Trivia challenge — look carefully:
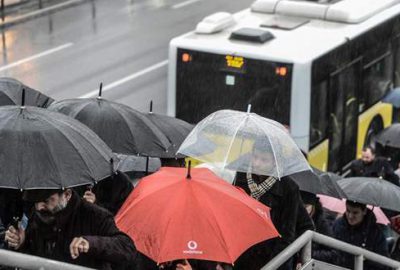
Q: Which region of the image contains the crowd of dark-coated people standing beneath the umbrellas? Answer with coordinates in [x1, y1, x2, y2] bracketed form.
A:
[0, 147, 400, 270]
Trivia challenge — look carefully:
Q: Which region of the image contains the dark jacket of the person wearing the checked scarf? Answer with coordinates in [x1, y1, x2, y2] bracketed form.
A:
[235, 173, 304, 270]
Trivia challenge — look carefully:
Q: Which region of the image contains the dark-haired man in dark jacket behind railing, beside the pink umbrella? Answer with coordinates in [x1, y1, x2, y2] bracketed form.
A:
[333, 200, 389, 270]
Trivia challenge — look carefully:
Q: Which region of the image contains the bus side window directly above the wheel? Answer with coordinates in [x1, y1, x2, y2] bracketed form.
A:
[362, 54, 393, 108]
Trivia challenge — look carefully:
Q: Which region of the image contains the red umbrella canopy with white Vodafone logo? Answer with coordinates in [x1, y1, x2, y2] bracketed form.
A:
[116, 167, 279, 264]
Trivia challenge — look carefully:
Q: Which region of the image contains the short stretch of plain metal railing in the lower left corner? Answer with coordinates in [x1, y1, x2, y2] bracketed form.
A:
[0, 249, 93, 270]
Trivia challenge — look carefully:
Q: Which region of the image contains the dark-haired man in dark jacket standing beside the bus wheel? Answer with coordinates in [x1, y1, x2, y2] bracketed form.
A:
[349, 146, 400, 186]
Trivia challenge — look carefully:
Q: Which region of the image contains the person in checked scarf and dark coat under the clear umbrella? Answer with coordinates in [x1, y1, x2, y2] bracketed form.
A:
[234, 140, 305, 270]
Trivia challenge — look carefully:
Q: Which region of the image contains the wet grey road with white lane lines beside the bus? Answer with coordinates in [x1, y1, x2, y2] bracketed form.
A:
[0, 0, 253, 113]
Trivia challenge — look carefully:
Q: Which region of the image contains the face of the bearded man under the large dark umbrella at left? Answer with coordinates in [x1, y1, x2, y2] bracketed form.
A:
[35, 191, 70, 223]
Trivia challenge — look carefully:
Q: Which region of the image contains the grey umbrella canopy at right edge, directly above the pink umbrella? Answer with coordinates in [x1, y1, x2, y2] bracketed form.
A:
[338, 177, 400, 211]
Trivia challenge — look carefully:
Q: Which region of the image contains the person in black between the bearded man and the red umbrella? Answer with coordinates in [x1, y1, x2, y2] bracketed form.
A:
[83, 171, 133, 215]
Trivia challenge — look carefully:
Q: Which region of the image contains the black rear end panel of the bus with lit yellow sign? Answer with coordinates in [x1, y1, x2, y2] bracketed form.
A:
[176, 49, 293, 125]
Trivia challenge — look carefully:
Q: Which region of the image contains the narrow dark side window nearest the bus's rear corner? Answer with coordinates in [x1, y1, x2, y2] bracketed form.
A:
[310, 81, 329, 147]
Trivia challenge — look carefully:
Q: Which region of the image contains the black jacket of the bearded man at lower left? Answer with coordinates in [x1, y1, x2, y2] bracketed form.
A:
[21, 193, 136, 269]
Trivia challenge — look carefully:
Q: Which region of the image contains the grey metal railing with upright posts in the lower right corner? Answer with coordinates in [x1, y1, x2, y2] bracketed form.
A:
[262, 231, 400, 270]
